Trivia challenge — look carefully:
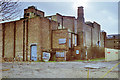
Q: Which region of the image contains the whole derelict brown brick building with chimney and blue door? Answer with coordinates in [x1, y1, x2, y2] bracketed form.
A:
[2, 6, 105, 61]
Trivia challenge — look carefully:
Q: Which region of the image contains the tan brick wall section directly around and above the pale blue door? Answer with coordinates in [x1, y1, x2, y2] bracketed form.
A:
[28, 17, 43, 60]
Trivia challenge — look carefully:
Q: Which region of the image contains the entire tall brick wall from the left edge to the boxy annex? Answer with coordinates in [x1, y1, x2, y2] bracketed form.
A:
[1, 17, 58, 60]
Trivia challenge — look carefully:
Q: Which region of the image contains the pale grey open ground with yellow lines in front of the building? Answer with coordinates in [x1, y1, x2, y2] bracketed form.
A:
[2, 61, 120, 78]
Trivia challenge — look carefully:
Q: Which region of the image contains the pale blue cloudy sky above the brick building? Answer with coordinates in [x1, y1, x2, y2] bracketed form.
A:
[15, 0, 118, 34]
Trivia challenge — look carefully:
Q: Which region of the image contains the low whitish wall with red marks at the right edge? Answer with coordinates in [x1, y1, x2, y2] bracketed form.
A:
[105, 48, 120, 61]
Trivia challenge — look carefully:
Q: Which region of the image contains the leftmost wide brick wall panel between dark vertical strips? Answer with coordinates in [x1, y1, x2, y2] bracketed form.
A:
[4, 22, 14, 58]
